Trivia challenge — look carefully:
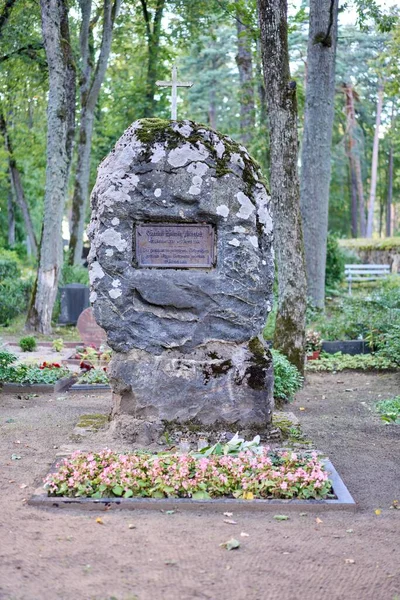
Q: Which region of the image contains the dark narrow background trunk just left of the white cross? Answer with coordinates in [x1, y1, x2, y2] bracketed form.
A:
[140, 0, 165, 117]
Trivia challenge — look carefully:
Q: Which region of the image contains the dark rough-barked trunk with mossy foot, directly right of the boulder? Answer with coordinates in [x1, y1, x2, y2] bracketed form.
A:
[258, 0, 306, 372]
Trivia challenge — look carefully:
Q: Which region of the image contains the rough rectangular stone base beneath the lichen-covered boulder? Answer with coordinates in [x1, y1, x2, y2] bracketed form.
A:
[109, 338, 273, 432]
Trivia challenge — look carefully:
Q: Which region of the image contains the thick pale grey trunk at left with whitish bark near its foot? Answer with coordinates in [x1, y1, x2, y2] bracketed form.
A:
[26, 0, 75, 334]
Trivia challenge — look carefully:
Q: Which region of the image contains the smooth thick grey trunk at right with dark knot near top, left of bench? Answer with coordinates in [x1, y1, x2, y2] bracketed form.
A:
[300, 0, 338, 309]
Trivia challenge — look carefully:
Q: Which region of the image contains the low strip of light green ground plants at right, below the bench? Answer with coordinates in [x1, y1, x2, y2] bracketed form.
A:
[306, 352, 398, 372]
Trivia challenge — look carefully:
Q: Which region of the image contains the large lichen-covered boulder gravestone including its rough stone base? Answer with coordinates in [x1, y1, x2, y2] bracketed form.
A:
[88, 119, 274, 441]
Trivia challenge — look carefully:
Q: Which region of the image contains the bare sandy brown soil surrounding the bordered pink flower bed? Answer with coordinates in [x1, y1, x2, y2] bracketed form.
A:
[0, 373, 400, 600]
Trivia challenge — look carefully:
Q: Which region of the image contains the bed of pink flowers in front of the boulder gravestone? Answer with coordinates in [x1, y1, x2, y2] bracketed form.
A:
[44, 446, 332, 499]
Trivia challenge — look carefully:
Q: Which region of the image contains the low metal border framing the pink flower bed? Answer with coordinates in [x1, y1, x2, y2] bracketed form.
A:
[28, 455, 357, 512]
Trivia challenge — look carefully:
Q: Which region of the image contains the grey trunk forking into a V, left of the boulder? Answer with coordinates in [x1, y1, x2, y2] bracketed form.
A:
[69, 0, 121, 264]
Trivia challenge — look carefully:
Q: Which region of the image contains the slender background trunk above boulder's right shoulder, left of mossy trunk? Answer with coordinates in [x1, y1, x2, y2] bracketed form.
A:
[236, 11, 255, 147]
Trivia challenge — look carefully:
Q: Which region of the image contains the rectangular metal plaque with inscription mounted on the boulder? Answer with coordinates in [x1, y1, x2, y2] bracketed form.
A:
[136, 223, 214, 268]
